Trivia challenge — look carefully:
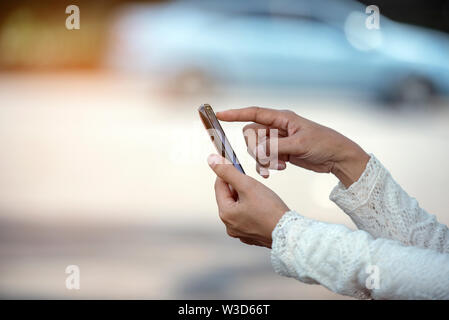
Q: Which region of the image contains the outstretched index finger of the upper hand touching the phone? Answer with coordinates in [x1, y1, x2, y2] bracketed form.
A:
[217, 107, 294, 130]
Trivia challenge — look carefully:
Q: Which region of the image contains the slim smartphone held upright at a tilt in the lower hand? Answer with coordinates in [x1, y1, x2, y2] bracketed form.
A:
[198, 104, 245, 174]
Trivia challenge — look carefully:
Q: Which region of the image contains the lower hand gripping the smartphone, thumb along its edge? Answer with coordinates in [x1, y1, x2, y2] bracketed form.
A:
[207, 154, 289, 248]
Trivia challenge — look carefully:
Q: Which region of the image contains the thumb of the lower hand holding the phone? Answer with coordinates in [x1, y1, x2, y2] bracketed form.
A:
[207, 154, 248, 190]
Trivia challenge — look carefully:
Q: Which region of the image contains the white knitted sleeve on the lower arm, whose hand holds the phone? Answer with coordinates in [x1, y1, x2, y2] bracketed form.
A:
[271, 211, 449, 299]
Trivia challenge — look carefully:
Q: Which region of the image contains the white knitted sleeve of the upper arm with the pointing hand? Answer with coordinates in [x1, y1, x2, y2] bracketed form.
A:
[330, 155, 449, 253]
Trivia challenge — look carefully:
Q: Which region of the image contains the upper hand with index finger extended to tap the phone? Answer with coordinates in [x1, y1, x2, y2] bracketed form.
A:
[217, 107, 370, 187]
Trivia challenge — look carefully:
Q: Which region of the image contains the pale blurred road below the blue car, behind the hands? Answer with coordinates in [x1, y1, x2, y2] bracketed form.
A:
[0, 73, 449, 299]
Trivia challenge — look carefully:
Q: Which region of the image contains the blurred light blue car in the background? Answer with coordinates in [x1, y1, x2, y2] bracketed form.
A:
[107, 0, 449, 103]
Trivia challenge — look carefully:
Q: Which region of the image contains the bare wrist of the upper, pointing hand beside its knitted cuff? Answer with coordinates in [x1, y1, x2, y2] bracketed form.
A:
[331, 143, 370, 188]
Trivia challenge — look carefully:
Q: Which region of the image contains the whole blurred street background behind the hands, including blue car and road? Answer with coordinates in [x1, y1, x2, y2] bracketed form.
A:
[0, 0, 449, 299]
